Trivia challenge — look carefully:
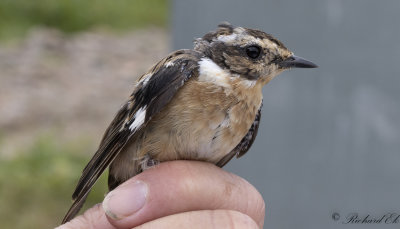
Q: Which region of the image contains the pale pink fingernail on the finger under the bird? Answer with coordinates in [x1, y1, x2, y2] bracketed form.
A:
[103, 181, 148, 220]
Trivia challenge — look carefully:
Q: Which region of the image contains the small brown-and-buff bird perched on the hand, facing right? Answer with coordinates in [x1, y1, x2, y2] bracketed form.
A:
[62, 22, 317, 223]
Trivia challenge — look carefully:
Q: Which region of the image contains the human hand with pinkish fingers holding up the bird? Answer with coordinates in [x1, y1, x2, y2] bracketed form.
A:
[58, 161, 265, 229]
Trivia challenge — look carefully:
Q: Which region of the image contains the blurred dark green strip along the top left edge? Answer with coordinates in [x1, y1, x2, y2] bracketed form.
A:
[0, 0, 168, 39]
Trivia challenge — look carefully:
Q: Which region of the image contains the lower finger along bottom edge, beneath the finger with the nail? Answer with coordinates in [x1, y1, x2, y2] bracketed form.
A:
[135, 210, 259, 229]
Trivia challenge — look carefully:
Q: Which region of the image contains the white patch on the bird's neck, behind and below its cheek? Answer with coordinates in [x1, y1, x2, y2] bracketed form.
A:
[199, 58, 231, 88]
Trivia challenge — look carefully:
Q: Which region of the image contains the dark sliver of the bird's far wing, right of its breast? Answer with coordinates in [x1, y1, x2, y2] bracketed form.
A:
[216, 104, 262, 167]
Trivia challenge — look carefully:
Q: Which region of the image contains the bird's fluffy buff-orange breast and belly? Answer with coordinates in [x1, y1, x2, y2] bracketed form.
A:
[139, 74, 262, 163]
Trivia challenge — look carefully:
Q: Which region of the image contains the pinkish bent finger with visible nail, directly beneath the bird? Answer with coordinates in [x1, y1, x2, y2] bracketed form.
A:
[103, 161, 265, 228]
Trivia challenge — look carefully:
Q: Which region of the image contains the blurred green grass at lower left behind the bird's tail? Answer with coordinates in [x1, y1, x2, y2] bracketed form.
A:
[0, 135, 107, 228]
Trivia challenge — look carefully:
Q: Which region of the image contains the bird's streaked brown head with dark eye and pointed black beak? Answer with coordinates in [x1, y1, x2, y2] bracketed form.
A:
[194, 23, 317, 84]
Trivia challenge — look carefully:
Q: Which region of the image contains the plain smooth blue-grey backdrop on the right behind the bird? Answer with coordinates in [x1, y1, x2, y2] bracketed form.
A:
[171, 0, 400, 229]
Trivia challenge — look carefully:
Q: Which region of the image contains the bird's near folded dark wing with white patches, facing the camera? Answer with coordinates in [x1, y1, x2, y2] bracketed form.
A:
[63, 50, 201, 223]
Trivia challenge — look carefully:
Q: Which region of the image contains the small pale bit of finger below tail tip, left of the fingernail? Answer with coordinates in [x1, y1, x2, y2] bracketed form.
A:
[56, 204, 115, 229]
